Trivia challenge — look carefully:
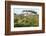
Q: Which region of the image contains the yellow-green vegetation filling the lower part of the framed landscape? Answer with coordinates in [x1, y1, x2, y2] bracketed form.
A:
[14, 15, 39, 27]
